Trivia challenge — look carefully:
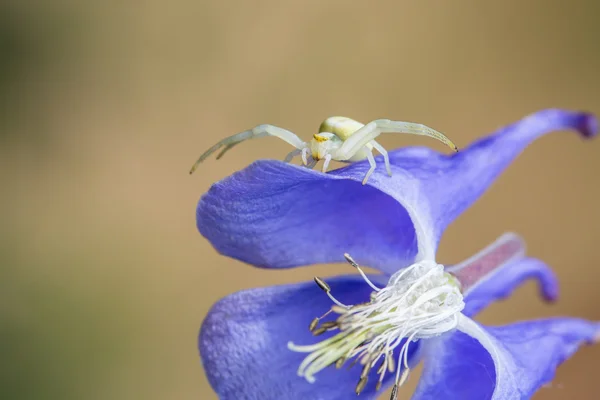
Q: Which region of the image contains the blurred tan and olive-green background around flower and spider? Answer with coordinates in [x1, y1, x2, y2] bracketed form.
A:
[0, 0, 600, 400]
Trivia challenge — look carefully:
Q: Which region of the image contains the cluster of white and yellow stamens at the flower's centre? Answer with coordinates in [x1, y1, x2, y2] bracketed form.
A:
[288, 255, 465, 394]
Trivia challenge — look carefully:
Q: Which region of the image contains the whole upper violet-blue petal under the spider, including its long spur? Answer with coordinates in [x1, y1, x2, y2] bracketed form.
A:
[196, 110, 596, 274]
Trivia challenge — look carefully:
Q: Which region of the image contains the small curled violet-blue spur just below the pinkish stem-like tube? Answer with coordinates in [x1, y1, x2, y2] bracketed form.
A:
[463, 258, 559, 317]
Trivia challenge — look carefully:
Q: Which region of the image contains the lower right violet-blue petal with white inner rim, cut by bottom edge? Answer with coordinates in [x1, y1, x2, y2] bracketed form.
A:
[413, 317, 600, 400]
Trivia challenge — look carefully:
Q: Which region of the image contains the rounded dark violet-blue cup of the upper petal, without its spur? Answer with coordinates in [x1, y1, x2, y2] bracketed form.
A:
[197, 160, 417, 275]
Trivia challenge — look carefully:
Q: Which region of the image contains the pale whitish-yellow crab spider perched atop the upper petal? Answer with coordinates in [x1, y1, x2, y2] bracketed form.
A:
[190, 117, 458, 185]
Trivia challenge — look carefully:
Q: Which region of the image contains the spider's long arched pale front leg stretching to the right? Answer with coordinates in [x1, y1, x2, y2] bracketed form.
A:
[333, 119, 458, 160]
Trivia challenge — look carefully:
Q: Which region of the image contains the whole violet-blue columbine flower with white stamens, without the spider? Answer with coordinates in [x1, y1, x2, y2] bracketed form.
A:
[197, 110, 600, 400]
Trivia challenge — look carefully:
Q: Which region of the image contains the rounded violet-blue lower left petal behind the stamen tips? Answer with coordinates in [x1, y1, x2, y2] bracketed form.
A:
[199, 276, 418, 400]
